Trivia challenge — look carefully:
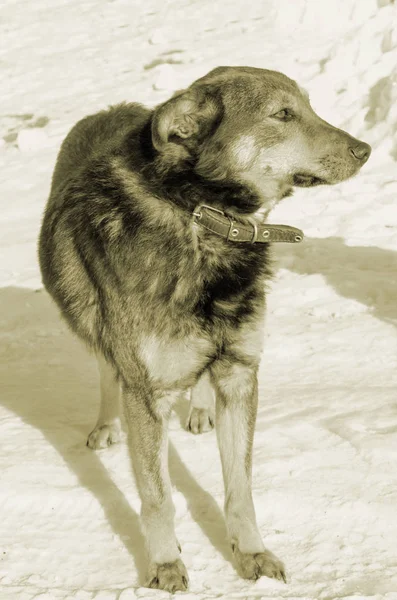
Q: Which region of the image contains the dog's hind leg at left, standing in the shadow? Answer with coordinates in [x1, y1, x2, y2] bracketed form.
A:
[87, 355, 121, 450]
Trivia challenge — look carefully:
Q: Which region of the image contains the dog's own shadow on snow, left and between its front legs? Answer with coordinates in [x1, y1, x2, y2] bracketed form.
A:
[0, 287, 232, 585]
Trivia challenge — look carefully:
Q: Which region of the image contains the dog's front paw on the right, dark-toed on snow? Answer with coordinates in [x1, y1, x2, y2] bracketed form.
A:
[232, 545, 287, 583]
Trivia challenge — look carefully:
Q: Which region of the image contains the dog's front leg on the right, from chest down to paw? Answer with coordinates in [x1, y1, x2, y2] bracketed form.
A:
[212, 360, 285, 581]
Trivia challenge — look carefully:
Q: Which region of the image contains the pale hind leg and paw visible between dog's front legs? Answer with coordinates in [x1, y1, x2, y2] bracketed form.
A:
[186, 371, 215, 433]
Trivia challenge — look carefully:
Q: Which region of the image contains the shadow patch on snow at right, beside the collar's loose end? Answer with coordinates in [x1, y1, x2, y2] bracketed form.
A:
[273, 237, 397, 325]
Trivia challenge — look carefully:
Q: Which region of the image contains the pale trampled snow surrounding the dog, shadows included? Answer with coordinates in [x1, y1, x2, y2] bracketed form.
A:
[0, 0, 397, 600]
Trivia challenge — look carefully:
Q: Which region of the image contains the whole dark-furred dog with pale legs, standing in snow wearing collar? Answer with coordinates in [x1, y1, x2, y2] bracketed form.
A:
[39, 67, 371, 592]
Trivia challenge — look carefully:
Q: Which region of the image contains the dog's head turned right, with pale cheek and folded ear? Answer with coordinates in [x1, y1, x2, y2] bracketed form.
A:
[152, 67, 371, 209]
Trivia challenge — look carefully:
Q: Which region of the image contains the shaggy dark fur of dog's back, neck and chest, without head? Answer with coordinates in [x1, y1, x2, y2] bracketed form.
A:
[40, 99, 269, 384]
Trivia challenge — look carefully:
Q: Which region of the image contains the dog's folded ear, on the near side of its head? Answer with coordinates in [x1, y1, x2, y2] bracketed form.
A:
[152, 88, 222, 159]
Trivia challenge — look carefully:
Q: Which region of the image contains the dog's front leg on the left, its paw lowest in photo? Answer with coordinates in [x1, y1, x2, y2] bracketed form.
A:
[122, 385, 188, 593]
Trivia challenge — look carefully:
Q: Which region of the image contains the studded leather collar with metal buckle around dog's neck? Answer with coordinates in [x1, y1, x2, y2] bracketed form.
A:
[193, 204, 304, 244]
